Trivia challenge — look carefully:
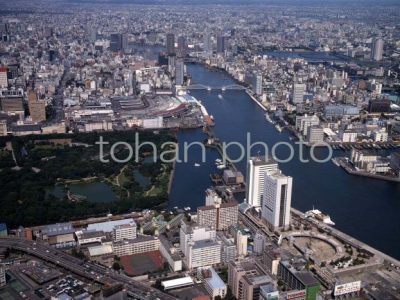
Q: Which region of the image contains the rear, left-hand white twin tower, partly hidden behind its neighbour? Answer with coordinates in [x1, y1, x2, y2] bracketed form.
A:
[246, 156, 278, 208]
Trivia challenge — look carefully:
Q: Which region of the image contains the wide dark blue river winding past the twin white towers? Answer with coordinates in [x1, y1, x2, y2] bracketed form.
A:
[169, 64, 400, 259]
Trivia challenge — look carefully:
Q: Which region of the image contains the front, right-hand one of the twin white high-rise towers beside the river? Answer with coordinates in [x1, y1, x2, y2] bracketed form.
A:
[262, 170, 293, 230]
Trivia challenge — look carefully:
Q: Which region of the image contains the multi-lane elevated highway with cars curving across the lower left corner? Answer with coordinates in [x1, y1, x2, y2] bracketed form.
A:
[0, 237, 176, 300]
